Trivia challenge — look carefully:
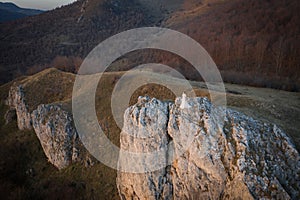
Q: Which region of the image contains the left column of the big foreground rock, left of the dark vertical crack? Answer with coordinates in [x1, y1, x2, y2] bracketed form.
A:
[117, 98, 172, 199]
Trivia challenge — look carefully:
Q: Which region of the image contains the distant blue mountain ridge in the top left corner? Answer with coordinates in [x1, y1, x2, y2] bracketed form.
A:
[0, 2, 44, 22]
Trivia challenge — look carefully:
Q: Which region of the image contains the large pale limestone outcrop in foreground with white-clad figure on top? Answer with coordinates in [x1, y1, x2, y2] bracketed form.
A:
[117, 97, 300, 199]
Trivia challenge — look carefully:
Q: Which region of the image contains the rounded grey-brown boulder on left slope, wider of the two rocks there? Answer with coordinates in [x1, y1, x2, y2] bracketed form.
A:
[31, 104, 79, 169]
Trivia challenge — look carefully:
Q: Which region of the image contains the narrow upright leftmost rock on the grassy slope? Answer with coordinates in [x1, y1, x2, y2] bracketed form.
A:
[7, 85, 32, 130]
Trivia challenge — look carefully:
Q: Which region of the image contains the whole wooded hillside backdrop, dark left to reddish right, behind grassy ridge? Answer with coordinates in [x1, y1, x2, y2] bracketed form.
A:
[0, 0, 300, 91]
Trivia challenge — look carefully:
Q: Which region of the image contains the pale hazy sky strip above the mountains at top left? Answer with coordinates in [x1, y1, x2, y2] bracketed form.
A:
[0, 0, 76, 10]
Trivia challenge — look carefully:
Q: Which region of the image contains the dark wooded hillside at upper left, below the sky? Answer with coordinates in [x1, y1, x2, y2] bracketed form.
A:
[0, 0, 154, 83]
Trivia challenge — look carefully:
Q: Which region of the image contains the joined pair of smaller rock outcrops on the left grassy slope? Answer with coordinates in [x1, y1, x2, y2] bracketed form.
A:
[5, 85, 86, 169]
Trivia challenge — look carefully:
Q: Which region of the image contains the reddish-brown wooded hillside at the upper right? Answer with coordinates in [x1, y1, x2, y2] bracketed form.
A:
[165, 0, 300, 89]
